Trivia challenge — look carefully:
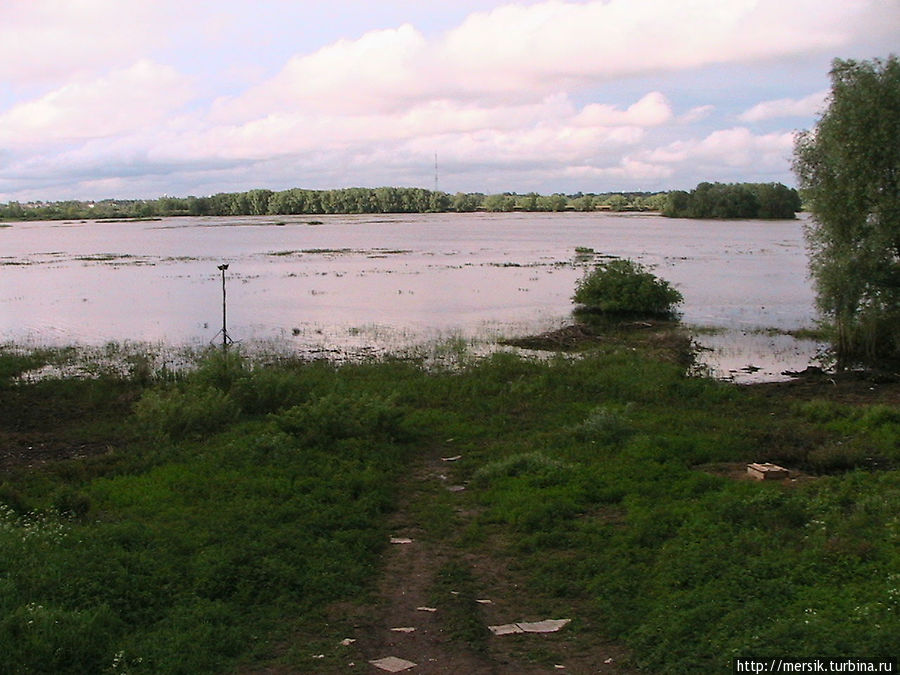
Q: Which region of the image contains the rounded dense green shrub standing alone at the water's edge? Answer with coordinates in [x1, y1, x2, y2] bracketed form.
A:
[572, 259, 683, 316]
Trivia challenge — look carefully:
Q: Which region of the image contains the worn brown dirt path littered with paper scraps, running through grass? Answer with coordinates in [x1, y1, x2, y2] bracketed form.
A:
[344, 452, 634, 675]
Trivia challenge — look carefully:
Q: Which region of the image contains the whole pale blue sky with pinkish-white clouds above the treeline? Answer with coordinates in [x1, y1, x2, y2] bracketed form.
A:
[0, 0, 900, 202]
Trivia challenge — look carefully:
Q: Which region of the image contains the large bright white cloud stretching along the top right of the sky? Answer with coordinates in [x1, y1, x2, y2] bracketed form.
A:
[216, 0, 874, 122]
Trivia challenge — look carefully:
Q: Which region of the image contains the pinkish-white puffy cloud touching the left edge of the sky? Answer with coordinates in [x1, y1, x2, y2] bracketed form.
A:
[0, 60, 191, 146]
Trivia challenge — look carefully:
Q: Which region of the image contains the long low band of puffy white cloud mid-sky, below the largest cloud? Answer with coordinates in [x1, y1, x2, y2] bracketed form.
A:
[160, 92, 671, 172]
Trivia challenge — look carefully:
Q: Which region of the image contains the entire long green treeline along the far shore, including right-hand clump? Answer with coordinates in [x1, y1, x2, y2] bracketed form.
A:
[0, 183, 800, 220]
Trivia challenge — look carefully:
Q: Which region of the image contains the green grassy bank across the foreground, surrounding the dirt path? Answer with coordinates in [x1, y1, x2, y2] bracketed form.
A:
[0, 329, 900, 674]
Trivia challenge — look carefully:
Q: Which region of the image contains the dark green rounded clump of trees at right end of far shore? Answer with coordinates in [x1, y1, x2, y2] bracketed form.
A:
[662, 183, 802, 219]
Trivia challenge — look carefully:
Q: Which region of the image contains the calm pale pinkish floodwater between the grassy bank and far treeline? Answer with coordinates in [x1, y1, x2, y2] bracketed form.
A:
[0, 213, 817, 379]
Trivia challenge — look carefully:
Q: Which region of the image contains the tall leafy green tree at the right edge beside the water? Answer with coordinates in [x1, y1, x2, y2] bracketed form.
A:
[793, 56, 900, 366]
